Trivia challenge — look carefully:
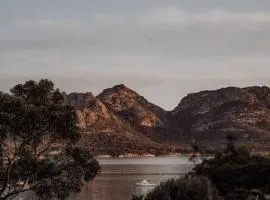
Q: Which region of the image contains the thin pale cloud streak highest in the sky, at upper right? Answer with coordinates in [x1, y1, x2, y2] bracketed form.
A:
[139, 7, 270, 25]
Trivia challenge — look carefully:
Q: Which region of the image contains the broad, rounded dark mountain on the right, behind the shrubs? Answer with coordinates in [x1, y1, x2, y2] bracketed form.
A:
[170, 87, 270, 151]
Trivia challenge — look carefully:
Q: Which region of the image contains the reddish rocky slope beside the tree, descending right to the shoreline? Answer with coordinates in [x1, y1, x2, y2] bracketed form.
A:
[64, 93, 177, 155]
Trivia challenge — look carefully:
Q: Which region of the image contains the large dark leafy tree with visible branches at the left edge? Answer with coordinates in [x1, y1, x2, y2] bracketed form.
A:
[0, 80, 100, 200]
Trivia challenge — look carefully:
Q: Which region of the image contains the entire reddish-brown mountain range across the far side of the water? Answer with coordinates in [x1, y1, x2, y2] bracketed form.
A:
[65, 85, 270, 154]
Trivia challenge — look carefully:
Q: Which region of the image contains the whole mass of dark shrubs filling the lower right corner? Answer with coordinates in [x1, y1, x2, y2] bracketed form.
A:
[133, 136, 270, 200]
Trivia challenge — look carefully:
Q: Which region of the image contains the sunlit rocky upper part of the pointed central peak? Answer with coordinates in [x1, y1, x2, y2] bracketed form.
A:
[97, 84, 167, 127]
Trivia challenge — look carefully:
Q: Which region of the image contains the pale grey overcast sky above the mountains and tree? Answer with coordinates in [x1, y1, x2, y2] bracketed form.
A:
[0, 0, 270, 110]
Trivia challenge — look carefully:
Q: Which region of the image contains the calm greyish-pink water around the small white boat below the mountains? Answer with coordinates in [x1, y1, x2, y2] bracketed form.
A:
[73, 157, 194, 200]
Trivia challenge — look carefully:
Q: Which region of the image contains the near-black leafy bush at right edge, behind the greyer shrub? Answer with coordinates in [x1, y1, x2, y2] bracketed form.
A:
[194, 136, 270, 200]
